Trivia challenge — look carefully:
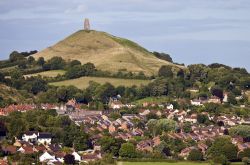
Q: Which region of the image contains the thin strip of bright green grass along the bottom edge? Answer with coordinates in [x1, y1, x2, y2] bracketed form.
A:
[117, 162, 209, 165]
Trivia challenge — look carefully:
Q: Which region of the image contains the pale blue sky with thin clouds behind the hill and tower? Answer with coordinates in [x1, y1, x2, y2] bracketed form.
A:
[0, 0, 250, 71]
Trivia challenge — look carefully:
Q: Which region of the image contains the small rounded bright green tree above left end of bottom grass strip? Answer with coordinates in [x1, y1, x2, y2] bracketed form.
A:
[119, 143, 136, 158]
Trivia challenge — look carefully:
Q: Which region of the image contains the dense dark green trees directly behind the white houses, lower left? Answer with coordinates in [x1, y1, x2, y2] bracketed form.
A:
[0, 110, 92, 151]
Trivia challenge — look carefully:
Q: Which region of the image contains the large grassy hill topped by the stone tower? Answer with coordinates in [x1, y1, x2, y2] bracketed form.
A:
[34, 30, 181, 75]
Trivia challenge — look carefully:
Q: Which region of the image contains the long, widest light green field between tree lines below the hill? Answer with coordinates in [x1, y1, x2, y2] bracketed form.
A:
[50, 77, 150, 89]
